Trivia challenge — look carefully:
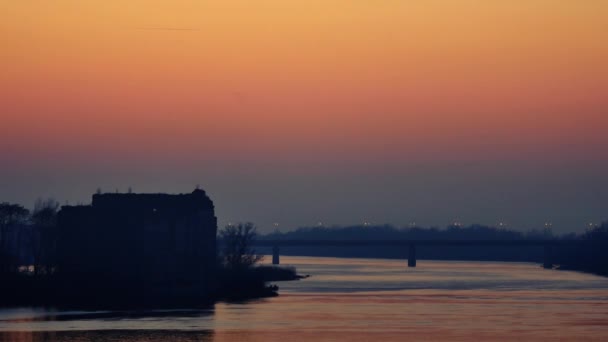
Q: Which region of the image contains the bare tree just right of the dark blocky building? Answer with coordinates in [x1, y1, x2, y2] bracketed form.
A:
[220, 223, 263, 269]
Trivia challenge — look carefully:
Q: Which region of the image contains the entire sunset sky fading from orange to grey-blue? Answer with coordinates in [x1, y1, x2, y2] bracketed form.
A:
[0, 0, 608, 231]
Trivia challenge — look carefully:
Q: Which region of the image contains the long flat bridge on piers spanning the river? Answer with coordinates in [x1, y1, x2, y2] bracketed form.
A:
[253, 240, 608, 268]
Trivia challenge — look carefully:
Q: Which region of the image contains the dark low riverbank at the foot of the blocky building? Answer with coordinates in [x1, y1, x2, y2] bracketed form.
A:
[0, 266, 306, 309]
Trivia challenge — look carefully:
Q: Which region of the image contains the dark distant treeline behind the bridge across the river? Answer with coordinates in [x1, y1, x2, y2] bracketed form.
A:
[260, 222, 608, 275]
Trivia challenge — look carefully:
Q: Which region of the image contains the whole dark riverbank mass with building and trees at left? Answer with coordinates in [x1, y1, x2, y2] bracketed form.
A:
[0, 189, 300, 307]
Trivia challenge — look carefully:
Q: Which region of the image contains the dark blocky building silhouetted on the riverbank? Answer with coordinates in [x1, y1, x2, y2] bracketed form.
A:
[57, 189, 217, 300]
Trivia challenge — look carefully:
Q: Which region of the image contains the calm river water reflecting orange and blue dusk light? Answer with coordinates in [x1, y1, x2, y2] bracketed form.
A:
[0, 257, 608, 342]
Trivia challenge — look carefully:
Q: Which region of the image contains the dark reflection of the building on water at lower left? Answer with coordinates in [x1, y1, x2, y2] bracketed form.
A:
[0, 307, 214, 342]
